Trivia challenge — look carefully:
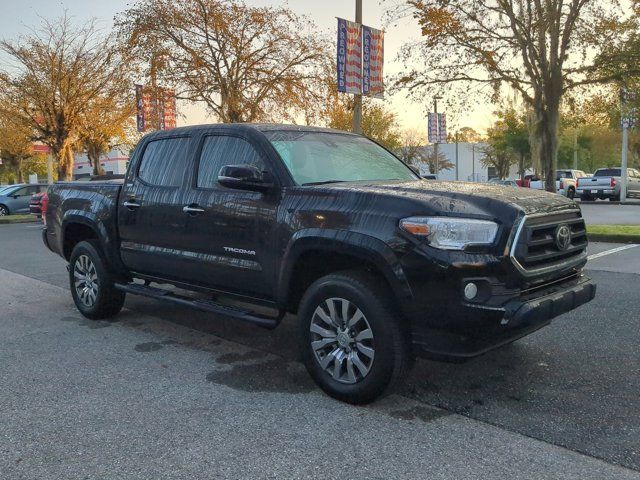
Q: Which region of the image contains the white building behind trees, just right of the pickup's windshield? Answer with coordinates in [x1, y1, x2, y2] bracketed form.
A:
[419, 143, 519, 182]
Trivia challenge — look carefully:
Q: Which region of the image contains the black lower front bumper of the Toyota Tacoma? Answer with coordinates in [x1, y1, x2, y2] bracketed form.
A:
[413, 276, 596, 362]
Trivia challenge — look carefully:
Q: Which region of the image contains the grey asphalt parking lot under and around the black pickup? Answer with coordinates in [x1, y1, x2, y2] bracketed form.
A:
[0, 223, 640, 479]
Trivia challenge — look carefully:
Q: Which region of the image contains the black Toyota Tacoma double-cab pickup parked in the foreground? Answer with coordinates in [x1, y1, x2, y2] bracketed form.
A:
[44, 125, 595, 403]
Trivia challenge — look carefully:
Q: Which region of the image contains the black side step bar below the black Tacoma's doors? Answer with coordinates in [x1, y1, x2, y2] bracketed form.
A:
[114, 283, 285, 329]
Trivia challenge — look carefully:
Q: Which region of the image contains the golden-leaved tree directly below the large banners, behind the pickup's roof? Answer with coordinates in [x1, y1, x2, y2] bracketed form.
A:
[325, 94, 402, 151]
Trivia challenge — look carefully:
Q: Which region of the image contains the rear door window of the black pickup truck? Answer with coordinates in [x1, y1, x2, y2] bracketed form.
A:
[138, 137, 190, 187]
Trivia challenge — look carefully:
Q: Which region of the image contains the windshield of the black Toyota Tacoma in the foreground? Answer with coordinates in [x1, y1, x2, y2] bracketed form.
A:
[265, 131, 418, 185]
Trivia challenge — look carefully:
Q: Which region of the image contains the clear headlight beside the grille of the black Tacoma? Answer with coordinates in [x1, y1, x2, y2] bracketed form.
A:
[400, 217, 498, 250]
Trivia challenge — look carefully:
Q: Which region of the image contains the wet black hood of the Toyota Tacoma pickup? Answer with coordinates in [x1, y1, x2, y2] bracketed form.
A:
[325, 180, 578, 215]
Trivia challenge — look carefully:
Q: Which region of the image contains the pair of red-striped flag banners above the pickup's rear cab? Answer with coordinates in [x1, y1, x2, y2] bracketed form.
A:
[136, 85, 176, 132]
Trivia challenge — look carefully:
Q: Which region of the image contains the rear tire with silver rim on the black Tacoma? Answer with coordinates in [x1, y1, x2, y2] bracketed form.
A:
[69, 240, 125, 320]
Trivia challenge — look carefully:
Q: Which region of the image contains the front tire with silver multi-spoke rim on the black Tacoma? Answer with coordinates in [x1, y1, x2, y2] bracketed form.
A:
[298, 270, 411, 404]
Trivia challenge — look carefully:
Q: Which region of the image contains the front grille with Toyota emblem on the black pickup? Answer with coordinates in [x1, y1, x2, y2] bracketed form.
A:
[512, 212, 587, 271]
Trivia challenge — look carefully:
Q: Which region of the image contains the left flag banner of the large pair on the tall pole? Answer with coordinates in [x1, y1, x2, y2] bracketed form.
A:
[337, 18, 362, 94]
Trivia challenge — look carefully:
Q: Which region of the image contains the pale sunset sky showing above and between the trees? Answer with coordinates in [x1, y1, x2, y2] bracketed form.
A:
[0, 0, 493, 134]
